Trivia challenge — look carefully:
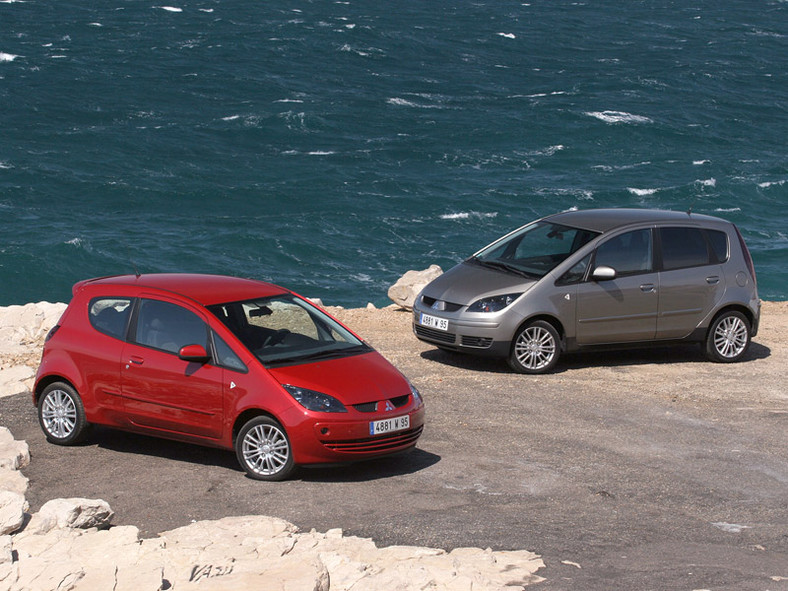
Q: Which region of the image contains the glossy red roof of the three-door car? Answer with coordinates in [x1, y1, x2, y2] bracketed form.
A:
[74, 273, 290, 306]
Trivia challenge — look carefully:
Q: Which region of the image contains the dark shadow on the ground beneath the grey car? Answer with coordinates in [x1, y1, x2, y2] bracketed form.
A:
[421, 342, 771, 374]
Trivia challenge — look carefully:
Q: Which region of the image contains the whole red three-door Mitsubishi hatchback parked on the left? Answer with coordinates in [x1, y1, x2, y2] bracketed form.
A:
[33, 274, 424, 480]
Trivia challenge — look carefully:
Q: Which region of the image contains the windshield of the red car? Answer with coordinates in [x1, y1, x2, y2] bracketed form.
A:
[208, 295, 370, 367]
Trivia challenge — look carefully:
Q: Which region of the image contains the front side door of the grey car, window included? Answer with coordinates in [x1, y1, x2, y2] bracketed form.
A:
[576, 228, 659, 345]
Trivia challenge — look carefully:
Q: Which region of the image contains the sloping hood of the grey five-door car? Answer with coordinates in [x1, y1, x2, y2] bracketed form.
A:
[422, 263, 536, 306]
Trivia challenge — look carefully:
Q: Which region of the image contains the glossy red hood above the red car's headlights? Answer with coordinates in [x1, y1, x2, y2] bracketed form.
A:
[268, 351, 410, 405]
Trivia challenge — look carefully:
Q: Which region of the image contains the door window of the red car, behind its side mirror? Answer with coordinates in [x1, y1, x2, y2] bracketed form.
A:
[134, 299, 208, 353]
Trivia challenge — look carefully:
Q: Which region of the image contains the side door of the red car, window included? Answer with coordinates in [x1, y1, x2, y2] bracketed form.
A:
[121, 297, 224, 439]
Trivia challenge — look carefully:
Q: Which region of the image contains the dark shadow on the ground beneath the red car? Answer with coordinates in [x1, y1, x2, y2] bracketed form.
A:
[91, 426, 441, 482]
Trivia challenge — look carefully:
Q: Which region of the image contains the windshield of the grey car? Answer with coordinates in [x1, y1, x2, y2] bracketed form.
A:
[468, 221, 599, 279]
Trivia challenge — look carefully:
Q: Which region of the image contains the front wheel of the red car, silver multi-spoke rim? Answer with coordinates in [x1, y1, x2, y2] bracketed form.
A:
[235, 415, 295, 481]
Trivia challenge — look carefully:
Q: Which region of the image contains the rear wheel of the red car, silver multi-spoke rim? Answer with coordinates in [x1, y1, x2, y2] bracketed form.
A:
[38, 382, 88, 445]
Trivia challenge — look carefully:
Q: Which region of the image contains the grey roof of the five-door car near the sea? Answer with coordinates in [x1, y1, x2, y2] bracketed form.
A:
[543, 208, 724, 232]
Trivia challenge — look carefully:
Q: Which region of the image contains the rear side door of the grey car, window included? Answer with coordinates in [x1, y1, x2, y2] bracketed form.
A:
[657, 227, 727, 339]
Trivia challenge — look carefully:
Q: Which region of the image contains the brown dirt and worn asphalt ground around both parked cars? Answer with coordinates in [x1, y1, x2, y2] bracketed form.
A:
[0, 302, 788, 591]
